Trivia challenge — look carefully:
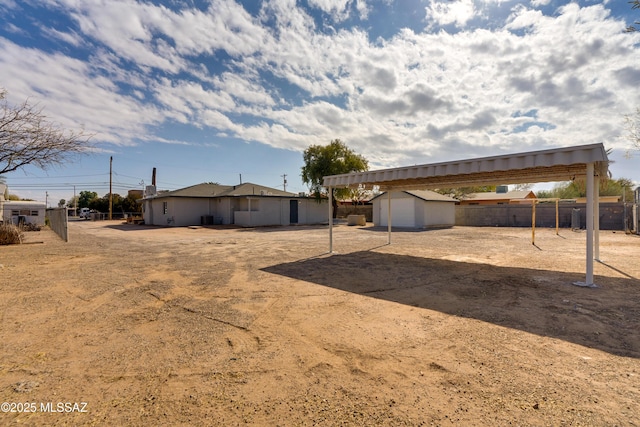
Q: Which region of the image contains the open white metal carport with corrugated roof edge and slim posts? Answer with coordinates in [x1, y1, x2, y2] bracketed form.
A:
[323, 143, 609, 286]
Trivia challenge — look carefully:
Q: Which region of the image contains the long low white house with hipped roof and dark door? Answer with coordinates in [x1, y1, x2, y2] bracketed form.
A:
[142, 183, 329, 227]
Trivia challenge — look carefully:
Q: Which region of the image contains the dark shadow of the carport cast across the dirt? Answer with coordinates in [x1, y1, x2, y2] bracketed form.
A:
[262, 251, 640, 358]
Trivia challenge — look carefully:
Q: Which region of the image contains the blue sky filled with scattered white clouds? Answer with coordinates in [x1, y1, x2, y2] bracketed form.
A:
[0, 0, 640, 206]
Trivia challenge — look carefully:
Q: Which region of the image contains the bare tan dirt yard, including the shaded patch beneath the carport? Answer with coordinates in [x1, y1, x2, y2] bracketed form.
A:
[0, 221, 640, 426]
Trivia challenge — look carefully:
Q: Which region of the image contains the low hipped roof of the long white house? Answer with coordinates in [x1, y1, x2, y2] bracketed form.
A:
[147, 182, 297, 199]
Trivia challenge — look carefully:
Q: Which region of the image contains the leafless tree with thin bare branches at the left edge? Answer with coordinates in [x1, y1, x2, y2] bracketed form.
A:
[0, 88, 92, 176]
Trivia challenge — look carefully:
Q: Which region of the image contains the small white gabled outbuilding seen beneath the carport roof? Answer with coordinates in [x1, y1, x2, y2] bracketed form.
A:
[371, 190, 457, 228]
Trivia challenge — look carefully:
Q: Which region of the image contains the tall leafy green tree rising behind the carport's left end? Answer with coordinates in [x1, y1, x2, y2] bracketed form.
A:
[301, 139, 369, 218]
